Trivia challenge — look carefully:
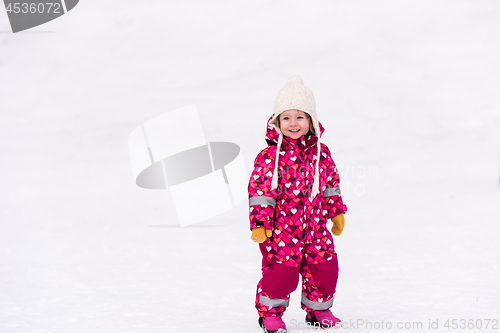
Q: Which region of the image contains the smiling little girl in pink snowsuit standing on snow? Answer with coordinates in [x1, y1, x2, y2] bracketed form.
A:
[248, 76, 347, 332]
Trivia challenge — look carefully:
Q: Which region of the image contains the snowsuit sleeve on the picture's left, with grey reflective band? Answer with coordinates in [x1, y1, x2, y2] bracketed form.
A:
[248, 146, 278, 229]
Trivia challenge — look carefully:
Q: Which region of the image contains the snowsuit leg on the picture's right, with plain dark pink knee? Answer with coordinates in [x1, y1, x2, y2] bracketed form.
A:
[300, 235, 339, 315]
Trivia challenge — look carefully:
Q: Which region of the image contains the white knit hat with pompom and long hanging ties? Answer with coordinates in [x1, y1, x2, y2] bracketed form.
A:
[269, 75, 321, 197]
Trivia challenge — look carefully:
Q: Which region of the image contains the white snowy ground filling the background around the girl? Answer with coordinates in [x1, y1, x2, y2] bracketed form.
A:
[0, 0, 500, 333]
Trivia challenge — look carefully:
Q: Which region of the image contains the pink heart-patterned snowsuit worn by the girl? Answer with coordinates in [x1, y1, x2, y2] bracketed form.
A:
[248, 117, 347, 317]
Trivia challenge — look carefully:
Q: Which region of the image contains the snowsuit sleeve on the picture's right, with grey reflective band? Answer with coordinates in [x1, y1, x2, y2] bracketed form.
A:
[322, 145, 347, 219]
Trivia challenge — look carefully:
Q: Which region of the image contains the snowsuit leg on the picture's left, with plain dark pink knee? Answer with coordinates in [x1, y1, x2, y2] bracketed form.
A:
[255, 242, 300, 317]
